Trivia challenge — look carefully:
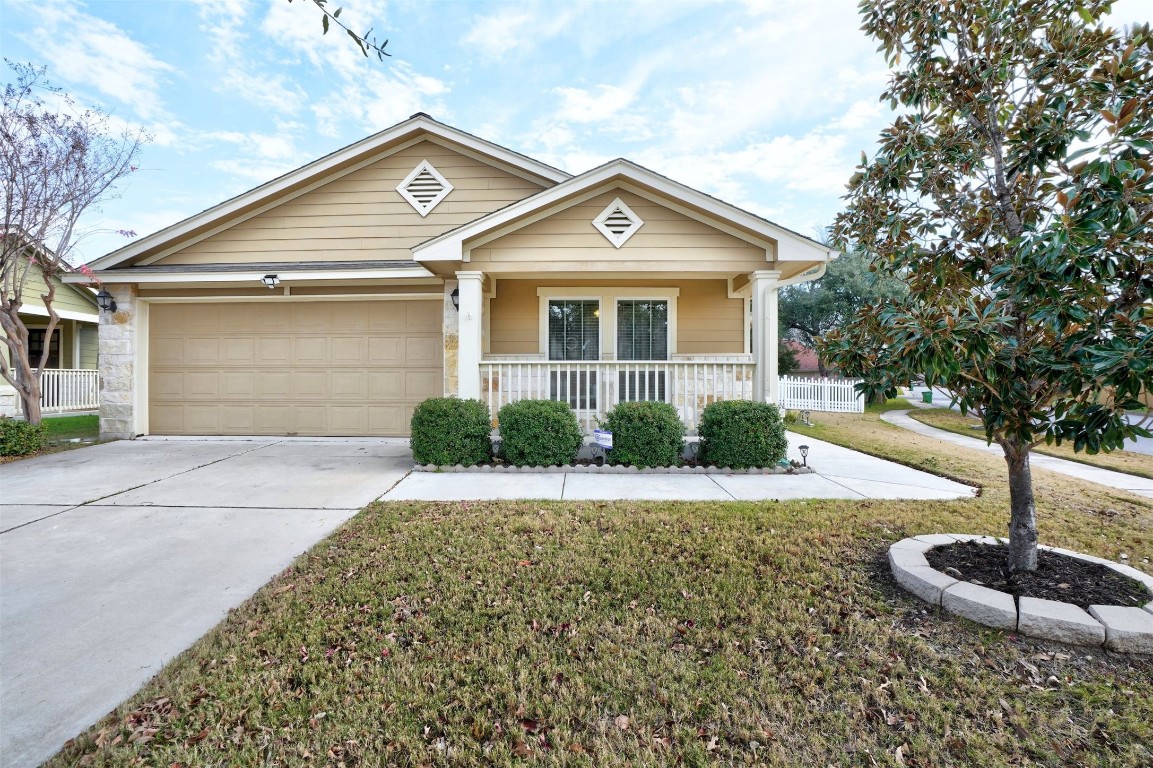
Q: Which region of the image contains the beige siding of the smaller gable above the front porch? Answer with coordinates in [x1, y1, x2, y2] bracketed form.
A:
[472, 190, 770, 274]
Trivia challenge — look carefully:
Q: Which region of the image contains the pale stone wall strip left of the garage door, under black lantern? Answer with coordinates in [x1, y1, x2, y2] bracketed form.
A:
[99, 285, 136, 439]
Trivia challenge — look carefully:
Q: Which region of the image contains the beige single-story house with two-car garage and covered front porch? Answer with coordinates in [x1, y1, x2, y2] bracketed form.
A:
[70, 113, 836, 437]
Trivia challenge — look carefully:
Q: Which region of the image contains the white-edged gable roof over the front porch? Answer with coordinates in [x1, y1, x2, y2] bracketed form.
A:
[413, 158, 837, 262]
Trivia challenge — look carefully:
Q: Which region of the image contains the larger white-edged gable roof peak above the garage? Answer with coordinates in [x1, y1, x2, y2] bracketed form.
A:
[91, 112, 572, 270]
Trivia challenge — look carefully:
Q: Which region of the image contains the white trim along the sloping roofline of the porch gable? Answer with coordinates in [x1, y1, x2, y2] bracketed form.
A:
[412, 159, 836, 262]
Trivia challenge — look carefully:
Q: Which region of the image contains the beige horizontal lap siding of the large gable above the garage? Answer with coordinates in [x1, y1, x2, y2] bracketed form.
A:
[158, 142, 541, 264]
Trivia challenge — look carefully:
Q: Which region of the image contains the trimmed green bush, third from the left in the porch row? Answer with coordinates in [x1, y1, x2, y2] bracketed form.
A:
[604, 402, 685, 467]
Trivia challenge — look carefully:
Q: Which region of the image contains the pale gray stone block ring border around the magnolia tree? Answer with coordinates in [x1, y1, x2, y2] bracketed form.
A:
[889, 534, 1153, 654]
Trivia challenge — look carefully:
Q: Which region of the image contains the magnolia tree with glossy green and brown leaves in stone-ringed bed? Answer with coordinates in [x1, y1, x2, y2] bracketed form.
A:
[824, 0, 1153, 572]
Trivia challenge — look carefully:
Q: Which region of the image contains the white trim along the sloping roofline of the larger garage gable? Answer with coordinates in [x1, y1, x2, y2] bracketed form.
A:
[91, 114, 572, 269]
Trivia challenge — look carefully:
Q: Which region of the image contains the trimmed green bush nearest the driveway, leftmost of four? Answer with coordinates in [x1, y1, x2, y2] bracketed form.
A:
[410, 398, 492, 467]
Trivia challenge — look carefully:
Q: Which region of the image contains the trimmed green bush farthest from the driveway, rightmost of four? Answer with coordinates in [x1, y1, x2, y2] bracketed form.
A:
[698, 400, 789, 469]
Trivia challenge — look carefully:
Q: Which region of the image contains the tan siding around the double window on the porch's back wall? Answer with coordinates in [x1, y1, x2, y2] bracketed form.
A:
[489, 277, 745, 356]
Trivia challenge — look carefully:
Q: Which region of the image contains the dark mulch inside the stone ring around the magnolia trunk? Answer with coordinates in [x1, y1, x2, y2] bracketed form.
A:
[925, 542, 1153, 609]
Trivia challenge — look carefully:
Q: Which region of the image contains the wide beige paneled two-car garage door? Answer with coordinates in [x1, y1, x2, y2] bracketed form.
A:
[149, 300, 443, 436]
